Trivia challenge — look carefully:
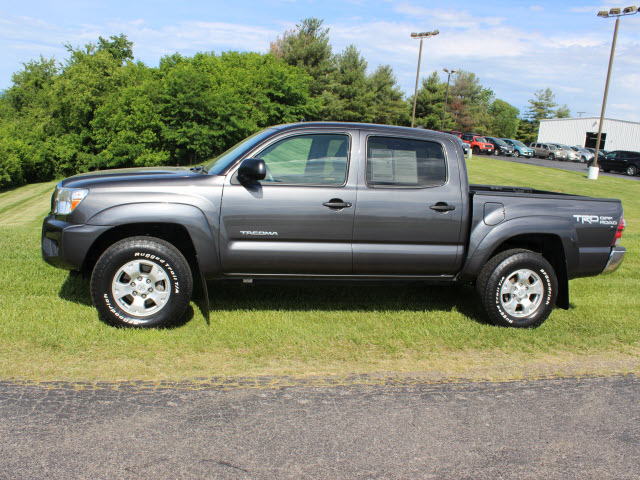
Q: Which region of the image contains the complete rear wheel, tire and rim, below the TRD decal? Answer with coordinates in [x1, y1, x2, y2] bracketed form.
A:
[476, 249, 558, 328]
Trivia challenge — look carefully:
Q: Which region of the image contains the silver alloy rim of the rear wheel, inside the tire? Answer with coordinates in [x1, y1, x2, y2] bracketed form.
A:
[500, 268, 544, 318]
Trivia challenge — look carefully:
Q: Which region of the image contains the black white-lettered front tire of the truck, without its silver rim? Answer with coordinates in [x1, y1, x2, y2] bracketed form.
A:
[91, 238, 193, 328]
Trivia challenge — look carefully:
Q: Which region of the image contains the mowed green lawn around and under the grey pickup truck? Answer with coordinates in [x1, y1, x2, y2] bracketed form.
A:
[0, 156, 640, 383]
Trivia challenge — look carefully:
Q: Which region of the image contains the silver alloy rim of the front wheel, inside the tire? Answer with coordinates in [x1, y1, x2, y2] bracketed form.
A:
[111, 260, 171, 317]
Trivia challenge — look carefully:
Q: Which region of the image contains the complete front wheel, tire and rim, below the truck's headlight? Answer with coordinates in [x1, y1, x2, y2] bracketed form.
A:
[91, 237, 193, 328]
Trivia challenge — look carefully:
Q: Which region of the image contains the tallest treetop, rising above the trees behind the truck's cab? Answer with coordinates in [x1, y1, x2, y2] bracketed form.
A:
[270, 17, 336, 96]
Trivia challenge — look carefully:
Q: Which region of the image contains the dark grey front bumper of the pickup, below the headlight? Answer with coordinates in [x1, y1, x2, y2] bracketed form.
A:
[41, 215, 111, 270]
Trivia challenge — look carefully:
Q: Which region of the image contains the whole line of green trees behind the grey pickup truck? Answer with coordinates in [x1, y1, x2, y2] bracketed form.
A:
[0, 18, 569, 188]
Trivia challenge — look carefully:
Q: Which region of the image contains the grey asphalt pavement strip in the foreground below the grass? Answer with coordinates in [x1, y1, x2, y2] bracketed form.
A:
[0, 376, 640, 479]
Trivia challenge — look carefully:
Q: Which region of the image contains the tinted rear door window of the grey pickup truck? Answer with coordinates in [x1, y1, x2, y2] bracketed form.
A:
[367, 137, 447, 187]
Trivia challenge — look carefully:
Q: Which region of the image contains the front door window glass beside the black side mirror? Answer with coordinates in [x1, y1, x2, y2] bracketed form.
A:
[256, 134, 349, 186]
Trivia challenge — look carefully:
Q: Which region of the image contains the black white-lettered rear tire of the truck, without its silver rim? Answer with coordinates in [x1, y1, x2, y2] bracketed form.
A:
[487, 253, 558, 328]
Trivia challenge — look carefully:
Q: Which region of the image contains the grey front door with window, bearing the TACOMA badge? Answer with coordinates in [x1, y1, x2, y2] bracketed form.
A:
[220, 130, 358, 275]
